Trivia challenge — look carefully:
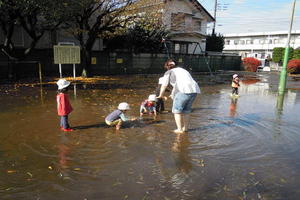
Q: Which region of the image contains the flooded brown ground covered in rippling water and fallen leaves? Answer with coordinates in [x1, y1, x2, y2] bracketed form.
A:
[0, 73, 300, 200]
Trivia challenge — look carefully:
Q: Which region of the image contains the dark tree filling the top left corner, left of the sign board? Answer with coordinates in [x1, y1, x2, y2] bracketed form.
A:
[0, 0, 64, 61]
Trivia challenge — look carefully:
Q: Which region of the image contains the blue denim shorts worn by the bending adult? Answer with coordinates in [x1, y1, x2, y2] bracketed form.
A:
[172, 92, 197, 114]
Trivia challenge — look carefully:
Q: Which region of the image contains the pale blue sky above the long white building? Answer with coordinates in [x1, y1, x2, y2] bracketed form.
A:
[198, 0, 300, 34]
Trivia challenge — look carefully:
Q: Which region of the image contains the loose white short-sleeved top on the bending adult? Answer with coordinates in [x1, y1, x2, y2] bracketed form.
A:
[162, 67, 201, 97]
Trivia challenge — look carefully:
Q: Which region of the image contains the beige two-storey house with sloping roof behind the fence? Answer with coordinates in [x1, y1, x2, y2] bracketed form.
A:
[163, 0, 214, 54]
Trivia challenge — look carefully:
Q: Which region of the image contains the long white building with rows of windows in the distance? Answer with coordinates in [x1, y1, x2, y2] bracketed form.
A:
[223, 30, 300, 59]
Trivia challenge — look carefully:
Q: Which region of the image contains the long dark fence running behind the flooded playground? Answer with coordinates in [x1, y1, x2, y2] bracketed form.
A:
[0, 49, 241, 78]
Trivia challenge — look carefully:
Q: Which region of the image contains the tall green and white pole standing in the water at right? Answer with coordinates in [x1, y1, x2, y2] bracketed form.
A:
[278, 0, 296, 95]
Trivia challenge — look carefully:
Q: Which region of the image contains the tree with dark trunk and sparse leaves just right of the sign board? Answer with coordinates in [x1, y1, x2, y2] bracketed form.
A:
[64, 0, 133, 76]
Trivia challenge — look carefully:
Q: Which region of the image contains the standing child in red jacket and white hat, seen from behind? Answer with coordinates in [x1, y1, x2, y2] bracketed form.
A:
[56, 79, 73, 131]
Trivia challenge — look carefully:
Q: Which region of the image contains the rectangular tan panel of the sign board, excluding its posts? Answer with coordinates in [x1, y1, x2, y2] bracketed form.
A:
[53, 45, 80, 64]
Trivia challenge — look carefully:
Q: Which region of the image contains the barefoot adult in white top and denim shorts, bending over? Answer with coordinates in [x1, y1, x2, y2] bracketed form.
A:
[157, 59, 201, 133]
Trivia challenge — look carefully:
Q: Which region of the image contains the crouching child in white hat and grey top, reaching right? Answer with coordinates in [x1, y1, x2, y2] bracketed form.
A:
[105, 102, 135, 130]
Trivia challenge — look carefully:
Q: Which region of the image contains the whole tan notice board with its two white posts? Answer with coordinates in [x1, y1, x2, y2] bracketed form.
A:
[53, 42, 80, 79]
